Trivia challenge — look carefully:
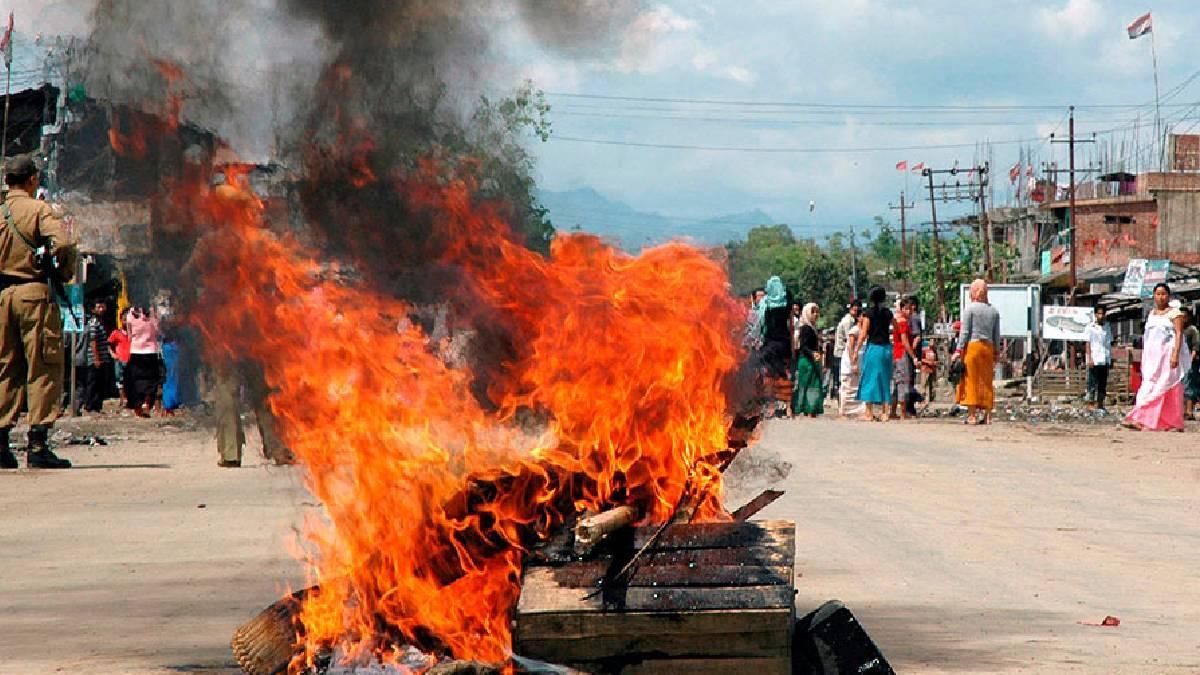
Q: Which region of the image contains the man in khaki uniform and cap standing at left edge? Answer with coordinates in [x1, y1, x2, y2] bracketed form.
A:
[0, 155, 76, 468]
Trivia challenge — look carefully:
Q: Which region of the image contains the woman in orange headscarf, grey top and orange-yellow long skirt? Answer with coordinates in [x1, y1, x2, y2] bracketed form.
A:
[954, 279, 1000, 424]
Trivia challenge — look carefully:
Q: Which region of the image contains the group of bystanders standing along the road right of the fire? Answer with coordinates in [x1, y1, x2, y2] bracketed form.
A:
[744, 276, 1200, 431]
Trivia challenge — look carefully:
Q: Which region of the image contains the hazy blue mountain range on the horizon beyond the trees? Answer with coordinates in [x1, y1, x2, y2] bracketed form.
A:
[538, 187, 775, 252]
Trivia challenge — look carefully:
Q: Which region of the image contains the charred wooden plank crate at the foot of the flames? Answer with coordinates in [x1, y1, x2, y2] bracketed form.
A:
[514, 521, 796, 675]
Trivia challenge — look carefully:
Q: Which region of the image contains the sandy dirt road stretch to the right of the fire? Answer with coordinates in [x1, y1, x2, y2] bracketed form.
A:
[731, 420, 1200, 674]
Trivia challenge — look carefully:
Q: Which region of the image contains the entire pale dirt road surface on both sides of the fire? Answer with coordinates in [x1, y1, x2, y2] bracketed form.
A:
[0, 408, 1200, 675]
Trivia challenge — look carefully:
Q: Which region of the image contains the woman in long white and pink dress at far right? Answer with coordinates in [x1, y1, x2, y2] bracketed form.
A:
[1122, 283, 1192, 431]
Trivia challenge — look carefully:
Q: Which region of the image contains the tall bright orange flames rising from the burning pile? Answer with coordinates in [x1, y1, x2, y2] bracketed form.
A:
[176, 157, 743, 667]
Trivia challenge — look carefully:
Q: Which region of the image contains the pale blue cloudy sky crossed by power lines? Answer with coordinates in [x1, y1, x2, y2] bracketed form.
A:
[10, 0, 1200, 235]
